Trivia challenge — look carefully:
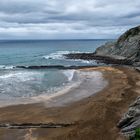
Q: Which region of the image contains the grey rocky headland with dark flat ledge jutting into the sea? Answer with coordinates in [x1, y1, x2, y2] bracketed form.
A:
[64, 26, 140, 67]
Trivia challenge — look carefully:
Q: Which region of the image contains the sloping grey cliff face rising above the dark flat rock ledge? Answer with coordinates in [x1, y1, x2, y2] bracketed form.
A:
[95, 26, 140, 66]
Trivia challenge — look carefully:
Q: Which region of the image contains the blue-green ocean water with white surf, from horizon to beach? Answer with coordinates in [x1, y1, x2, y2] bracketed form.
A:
[0, 40, 109, 104]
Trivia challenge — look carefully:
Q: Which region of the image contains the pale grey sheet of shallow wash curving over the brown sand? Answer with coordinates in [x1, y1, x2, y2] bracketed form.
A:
[33, 70, 107, 107]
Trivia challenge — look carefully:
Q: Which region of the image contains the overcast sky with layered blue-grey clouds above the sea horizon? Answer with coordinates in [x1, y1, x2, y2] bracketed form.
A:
[0, 0, 140, 39]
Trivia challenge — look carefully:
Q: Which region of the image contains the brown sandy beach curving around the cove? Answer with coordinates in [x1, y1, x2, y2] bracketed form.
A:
[0, 67, 140, 140]
